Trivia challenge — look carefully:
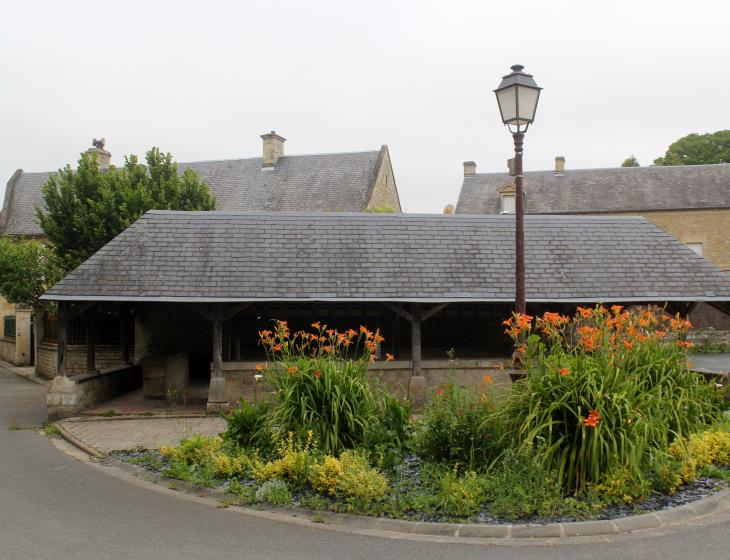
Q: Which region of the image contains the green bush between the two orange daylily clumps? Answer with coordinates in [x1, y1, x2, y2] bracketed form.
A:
[414, 376, 496, 469]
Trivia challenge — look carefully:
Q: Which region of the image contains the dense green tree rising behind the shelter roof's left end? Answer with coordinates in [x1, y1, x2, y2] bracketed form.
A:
[36, 148, 215, 272]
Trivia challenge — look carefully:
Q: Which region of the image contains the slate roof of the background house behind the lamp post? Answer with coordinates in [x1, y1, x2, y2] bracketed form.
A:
[456, 164, 730, 214]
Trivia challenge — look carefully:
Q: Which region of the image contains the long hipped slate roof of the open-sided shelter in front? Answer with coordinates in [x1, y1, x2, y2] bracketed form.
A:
[43, 211, 730, 303]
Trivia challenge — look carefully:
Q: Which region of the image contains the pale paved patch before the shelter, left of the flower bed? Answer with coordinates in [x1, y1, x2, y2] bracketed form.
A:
[59, 416, 226, 453]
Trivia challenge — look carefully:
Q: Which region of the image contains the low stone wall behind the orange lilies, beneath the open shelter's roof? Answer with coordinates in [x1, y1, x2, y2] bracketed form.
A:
[223, 358, 516, 404]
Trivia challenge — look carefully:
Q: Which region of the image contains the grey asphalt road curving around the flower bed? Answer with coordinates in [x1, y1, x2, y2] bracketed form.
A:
[0, 367, 730, 560]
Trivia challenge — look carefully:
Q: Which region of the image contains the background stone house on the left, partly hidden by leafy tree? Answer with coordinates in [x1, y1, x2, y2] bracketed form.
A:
[0, 131, 401, 375]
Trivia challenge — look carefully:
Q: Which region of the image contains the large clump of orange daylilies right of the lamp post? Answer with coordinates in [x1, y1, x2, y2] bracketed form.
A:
[500, 306, 719, 492]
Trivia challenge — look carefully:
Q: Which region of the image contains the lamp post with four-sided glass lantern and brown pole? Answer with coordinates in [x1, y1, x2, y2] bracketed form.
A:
[494, 64, 542, 313]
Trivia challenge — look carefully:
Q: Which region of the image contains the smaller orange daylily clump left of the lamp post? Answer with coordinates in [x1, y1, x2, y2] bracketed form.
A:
[259, 321, 404, 453]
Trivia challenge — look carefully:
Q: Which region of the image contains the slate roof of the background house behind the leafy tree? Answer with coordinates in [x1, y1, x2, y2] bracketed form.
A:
[0, 146, 387, 235]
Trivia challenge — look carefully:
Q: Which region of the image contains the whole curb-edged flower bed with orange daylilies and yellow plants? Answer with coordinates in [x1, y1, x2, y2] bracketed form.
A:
[116, 312, 730, 522]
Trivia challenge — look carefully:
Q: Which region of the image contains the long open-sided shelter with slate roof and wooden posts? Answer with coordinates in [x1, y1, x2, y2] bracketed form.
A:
[43, 211, 730, 415]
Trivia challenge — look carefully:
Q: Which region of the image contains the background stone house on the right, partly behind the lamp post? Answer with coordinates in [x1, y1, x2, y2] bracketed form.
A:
[456, 157, 730, 330]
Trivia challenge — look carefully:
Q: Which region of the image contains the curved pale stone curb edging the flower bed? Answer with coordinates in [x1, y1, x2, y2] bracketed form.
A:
[56, 417, 730, 542]
